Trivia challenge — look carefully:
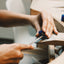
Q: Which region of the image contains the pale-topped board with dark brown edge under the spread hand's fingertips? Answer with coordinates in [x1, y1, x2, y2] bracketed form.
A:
[39, 33, 64, 45]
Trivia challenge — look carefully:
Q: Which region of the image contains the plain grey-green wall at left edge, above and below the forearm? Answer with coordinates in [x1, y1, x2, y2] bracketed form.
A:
[0, 0, 14, 39]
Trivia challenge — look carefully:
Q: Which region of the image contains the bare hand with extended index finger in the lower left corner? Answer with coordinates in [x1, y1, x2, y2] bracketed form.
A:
[0, 44, 33, 64]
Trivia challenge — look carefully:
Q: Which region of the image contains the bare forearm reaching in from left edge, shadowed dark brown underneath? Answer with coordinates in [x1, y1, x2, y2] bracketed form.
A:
[0, 10, 32, 27]
